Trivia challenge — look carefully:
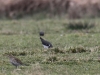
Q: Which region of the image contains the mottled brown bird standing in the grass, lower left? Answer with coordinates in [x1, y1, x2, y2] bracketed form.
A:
[7, 54, 23, 68]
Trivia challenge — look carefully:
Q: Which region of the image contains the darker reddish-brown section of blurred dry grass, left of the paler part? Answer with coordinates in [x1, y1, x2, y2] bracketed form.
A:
[0, 0, 69, 17]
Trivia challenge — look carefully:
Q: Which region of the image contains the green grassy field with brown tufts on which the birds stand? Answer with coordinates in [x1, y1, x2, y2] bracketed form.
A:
[0, 17, 100, 75]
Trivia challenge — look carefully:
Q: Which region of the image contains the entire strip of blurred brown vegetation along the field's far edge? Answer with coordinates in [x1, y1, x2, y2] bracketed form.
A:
[0, 0, 100, 19]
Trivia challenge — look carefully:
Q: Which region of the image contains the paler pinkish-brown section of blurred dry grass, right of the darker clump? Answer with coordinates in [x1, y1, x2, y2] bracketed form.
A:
[68, 0, 100, 18]
